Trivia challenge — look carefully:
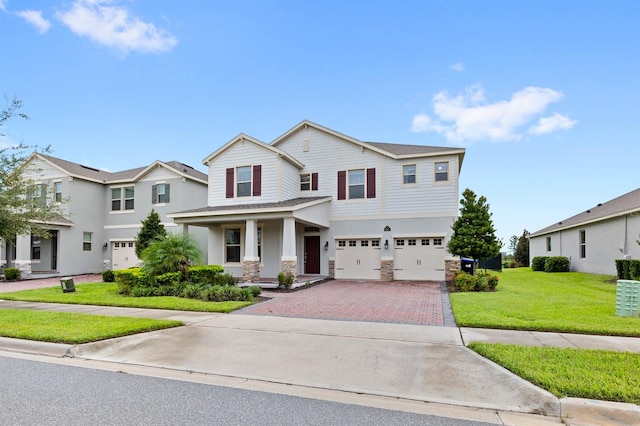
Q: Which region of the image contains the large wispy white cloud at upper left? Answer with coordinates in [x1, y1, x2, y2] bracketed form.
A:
[56, 0, 178, 52]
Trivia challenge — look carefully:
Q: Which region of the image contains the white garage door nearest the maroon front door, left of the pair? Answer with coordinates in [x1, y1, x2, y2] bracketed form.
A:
[335, 239, 380, 280]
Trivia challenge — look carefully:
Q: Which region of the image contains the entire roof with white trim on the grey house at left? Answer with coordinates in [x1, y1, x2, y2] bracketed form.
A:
[26, 153, 207, 184]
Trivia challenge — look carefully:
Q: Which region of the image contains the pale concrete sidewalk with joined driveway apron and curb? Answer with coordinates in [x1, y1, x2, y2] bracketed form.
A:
[0, 301, 640, 424]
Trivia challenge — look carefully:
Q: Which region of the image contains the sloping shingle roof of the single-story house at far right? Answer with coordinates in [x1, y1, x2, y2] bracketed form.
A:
[529, 188, 640, 238]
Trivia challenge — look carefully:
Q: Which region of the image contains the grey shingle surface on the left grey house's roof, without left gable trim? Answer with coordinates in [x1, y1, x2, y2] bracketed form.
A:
[38, 154, 207, 183]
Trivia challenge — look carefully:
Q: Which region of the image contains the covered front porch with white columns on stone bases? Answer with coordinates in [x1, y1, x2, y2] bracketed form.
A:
[168, 197, 331, 284]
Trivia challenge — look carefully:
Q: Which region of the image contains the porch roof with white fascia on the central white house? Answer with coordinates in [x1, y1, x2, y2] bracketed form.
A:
[167, 197, 331, 228]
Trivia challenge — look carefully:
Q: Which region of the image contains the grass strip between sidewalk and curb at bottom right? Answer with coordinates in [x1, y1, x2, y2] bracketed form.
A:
[469, 343, 640, 404]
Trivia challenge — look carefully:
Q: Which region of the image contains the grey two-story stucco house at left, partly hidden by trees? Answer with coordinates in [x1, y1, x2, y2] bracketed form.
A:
[0, 153, 207, 278]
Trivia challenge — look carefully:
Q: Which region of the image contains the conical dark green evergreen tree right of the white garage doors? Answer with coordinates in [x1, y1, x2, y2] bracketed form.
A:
[447, 188, 502, 266]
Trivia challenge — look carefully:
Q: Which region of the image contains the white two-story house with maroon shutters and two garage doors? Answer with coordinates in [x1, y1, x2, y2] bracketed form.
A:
[169, 121, 465, 282]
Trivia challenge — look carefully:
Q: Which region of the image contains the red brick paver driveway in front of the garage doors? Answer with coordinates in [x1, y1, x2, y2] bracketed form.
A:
[236, 280, 455, 326]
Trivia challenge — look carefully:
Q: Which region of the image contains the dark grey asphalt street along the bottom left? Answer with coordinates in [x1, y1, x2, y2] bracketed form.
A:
[0, 357, 489, 426]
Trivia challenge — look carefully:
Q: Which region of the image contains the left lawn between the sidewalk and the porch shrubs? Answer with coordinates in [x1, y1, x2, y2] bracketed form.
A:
[0, 283, 253, 313]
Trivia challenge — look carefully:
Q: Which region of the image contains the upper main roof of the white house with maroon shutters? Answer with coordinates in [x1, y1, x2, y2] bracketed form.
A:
[271, 120, 465, 166]
